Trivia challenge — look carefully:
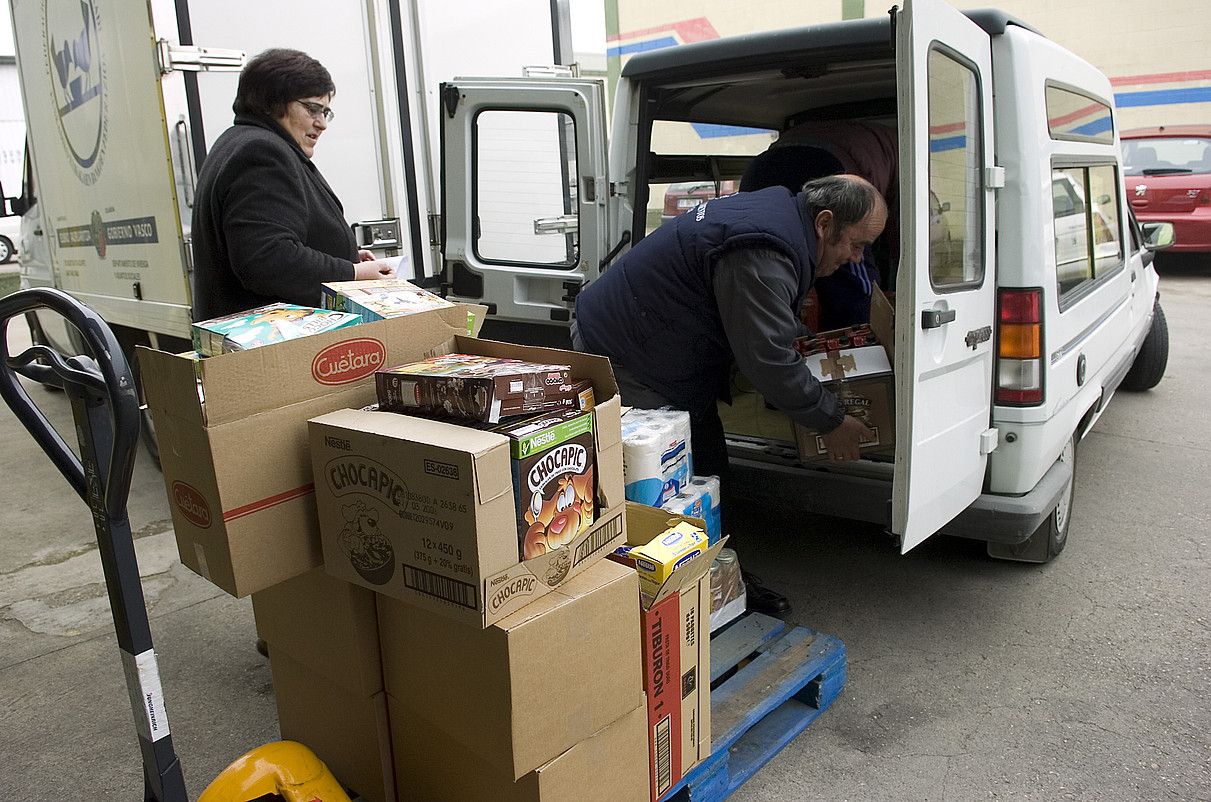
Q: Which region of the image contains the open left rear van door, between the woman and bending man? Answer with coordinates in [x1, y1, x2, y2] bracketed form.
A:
[438, 78, 609, 326]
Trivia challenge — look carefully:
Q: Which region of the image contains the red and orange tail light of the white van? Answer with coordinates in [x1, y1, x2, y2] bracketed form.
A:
[995, 290, 1043, 407]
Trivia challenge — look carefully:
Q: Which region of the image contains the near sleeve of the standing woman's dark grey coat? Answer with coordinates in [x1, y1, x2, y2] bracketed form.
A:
[223, 141, 354, 307]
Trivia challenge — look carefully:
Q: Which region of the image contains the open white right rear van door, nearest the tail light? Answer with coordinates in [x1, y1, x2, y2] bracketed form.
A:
[891, 0, 999, 551]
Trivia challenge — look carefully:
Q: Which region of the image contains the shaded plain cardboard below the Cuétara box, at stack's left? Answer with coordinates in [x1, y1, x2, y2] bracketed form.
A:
[252, 568, 395, 802]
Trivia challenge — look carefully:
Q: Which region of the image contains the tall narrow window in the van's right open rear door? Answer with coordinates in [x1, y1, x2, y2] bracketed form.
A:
[929, 50, 985, 288]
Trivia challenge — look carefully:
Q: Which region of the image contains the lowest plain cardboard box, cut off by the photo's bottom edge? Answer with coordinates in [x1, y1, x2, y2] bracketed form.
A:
[389, 698, 648, 802]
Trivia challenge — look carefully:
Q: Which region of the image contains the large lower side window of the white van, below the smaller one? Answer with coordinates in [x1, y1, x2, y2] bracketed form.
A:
[1051, 165, 1123, 303]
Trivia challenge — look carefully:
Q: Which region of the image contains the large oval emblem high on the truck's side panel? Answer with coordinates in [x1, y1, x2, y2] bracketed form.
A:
[44, 0, 108, 187]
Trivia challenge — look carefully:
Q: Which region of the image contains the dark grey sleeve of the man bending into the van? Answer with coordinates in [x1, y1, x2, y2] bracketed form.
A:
[712, 248, 845, 432]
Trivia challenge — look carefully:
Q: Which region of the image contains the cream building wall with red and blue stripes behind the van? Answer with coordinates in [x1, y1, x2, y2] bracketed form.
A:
[606, 0, 1211, 130]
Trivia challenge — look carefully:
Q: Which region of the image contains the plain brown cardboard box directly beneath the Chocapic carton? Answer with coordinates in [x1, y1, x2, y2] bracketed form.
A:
[378, 560, 643, 780]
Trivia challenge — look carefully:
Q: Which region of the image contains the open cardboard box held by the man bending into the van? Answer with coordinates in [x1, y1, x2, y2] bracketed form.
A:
[793, 287, 896, 463]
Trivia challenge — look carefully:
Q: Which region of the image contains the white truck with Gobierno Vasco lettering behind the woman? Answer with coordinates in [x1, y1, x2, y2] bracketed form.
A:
[12, 0, 567, 356]
